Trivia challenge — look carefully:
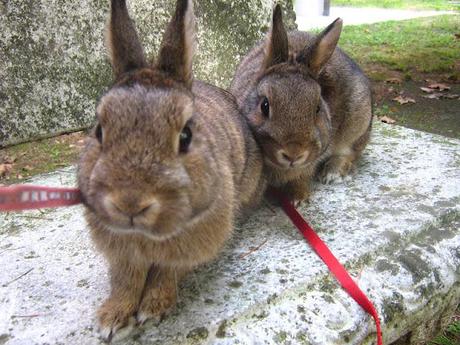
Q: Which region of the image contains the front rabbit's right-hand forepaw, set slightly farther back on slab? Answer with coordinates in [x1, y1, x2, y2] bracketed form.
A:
[137, 285, 176, 324]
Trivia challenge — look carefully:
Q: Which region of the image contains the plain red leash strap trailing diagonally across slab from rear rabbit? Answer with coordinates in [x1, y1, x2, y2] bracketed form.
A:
[272, 191, 383, 345]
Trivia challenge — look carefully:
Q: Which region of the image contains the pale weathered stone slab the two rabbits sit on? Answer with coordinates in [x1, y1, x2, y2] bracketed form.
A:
[0, 123, 460, 345]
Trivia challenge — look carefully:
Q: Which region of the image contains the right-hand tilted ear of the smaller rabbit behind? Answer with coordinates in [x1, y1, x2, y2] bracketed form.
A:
[297, 18, 342, 76]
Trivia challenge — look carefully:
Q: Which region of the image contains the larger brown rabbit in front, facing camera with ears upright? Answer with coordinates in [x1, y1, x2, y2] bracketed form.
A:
[78, 0, 264, 340]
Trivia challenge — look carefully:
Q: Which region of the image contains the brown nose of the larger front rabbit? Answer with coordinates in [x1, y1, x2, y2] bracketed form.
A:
[106, 196, 160, 220]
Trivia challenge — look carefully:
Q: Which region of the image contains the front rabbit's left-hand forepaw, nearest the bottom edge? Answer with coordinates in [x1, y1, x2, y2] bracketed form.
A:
[97, 298, 136, 342]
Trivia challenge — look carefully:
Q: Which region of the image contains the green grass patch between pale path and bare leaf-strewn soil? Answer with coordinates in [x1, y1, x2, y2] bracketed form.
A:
[339, 15, 460, 77]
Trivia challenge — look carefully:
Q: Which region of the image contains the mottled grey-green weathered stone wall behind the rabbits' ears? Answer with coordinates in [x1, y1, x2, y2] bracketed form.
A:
[0, 0, 295, 147]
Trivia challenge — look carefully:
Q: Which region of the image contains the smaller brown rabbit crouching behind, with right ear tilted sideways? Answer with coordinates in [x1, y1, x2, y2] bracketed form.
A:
[230, 5, 372, 201]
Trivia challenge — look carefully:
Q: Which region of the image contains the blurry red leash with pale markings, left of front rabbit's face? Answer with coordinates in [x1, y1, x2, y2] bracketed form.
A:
[0, 185, 81, 211]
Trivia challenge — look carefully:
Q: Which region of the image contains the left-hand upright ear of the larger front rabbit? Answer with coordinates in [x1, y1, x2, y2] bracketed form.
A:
[107, 0, 147, 77]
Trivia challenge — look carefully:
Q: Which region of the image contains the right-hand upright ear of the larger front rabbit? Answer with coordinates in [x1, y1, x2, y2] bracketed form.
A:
[157, 0, 195, 87]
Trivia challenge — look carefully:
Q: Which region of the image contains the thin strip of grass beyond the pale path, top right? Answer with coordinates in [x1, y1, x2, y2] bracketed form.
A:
[331, 0, 460, 11]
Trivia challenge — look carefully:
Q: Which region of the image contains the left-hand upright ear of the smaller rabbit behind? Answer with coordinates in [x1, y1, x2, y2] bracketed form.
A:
[264, 4, 289, 68]
